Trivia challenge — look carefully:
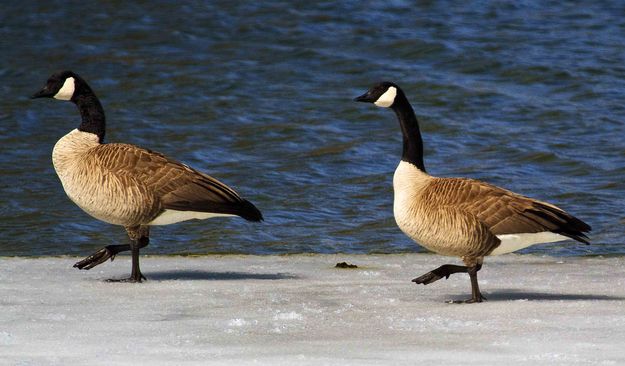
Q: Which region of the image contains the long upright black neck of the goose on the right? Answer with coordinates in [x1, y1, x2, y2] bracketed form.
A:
[392, 93, 425, 172]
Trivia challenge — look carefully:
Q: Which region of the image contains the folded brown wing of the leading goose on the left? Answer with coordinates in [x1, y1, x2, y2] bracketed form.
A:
[90, 144, 262, 221]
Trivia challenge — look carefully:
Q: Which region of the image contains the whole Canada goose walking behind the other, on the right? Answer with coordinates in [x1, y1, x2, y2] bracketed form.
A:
[355, 82, 591, 303]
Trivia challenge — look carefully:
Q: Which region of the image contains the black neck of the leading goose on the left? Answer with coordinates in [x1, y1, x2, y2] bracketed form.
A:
[72, 84, 106, 143]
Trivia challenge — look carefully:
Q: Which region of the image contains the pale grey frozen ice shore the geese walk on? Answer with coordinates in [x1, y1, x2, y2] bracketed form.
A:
[0, 254, 625, 365]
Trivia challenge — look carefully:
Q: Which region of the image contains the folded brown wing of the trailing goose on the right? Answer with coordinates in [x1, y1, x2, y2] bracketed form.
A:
[424, 178, 591, 244]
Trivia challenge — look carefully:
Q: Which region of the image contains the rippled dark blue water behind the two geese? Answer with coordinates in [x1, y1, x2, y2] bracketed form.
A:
[0, 1, 625, 255]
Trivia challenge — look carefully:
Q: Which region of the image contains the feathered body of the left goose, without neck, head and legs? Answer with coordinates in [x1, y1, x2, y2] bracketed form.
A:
[52, 129, 255, 226]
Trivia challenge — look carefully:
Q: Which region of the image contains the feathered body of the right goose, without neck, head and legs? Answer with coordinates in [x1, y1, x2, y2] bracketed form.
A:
[393, 161, 584, 257]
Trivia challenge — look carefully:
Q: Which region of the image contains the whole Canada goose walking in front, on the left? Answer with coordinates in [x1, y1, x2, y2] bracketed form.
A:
[32, 71, 263, 282]
